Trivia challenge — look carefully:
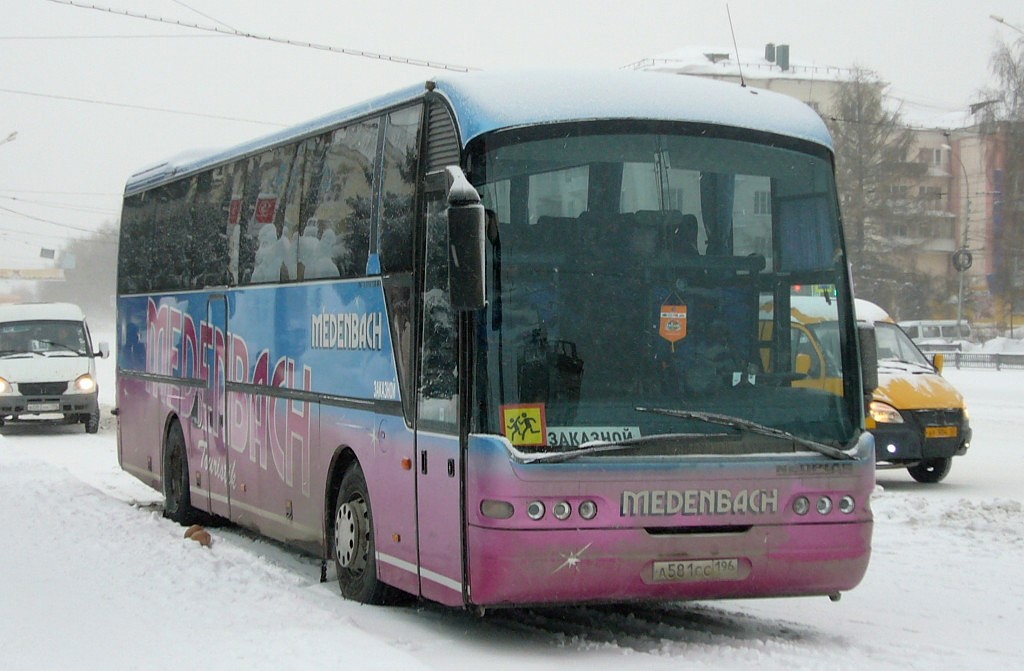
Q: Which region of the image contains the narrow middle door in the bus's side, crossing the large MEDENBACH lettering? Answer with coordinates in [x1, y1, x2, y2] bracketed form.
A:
[203, 294, 232, 518]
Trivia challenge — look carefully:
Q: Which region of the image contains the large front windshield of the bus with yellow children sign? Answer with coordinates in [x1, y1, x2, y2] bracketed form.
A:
[470, 121, 859, 454]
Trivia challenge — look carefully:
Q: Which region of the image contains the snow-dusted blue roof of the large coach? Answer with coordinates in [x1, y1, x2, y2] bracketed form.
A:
[125, 70, 833, 195]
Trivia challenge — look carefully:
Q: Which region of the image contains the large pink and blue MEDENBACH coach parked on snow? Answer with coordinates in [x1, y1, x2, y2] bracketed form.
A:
[117, 72, 876, 609]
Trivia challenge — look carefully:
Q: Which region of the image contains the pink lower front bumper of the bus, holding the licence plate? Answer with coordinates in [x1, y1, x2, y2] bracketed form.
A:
[468, 520, 872, 606]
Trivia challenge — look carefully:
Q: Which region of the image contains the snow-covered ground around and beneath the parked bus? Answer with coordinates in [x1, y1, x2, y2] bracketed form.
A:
[0, 361, 1024, 671]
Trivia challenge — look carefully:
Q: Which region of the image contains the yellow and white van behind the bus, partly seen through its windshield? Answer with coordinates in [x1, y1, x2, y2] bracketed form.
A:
[761, 296, 971, 483]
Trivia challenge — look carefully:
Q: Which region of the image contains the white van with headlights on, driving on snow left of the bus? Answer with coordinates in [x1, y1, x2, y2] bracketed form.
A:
[0, 303, 111, 433]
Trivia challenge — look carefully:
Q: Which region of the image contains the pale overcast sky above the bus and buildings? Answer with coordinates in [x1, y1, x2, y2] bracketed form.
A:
[0, 0, 1024, 267]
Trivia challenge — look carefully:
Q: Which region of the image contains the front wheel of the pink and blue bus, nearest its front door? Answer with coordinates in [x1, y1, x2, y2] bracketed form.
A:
[334, 464, 386, 603]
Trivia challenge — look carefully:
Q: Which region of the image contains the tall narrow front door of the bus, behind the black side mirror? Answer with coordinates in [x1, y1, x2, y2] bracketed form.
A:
[416, 191, 464, 605]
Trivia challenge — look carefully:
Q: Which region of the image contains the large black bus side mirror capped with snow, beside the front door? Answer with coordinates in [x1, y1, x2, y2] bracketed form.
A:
[444, 166, 486, 310]
